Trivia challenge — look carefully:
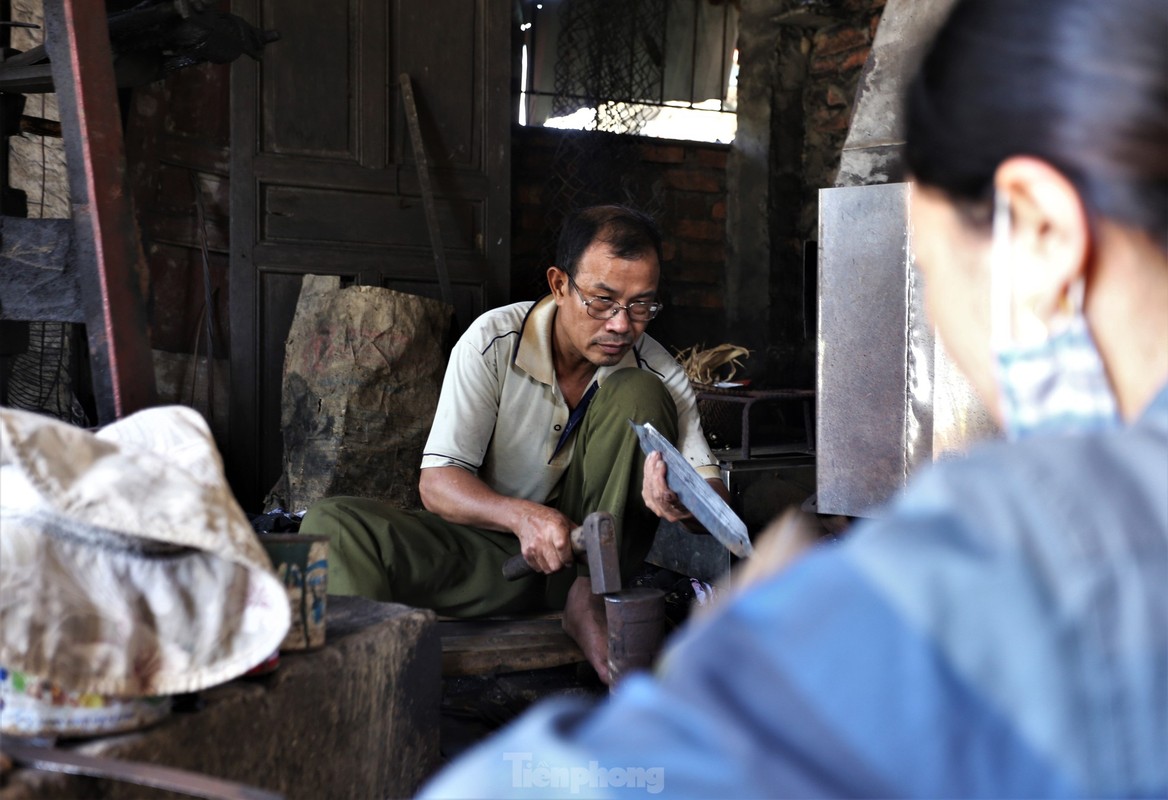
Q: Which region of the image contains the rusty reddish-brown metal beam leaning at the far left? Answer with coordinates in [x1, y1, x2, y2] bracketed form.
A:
[44, 0, 158, 424]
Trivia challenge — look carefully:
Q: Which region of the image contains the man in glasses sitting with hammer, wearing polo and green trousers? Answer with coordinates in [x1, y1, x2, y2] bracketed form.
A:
[300, 206, 725, 682]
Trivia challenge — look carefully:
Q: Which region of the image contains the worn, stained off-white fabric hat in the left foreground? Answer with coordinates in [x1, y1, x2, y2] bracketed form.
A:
[0, 406, 290, 697]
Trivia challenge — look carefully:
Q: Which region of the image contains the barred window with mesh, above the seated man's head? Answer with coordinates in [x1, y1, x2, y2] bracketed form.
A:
[516, 0, 738, 142]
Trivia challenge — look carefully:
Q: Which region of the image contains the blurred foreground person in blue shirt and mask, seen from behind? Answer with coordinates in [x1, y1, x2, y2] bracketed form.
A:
[415, 0, 1168, 798]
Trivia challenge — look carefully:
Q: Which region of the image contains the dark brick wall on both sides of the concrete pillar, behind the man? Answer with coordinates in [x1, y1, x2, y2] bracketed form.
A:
[512, 0, 884, 373]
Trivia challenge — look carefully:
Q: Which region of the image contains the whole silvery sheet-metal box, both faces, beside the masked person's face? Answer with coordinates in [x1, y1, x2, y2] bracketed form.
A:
[816, 183, 995, 516]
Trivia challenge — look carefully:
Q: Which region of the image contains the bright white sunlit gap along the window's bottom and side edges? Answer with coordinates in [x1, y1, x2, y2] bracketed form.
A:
[519, 44, 738, 144]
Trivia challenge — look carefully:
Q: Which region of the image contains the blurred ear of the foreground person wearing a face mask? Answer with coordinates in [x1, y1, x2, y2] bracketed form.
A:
[994, 156, 1091, 321]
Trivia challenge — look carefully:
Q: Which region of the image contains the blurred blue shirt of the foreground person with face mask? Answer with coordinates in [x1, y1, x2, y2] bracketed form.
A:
[426, 387, 1168, 798]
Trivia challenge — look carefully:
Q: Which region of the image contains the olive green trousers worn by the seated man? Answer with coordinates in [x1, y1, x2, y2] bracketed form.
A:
[300, 369, 677, 617]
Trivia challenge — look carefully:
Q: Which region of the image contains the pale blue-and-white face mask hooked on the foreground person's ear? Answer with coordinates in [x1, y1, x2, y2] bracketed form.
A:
[990, 194, 1121, 441]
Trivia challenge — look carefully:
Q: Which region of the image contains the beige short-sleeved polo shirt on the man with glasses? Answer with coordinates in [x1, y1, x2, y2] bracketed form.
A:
[422, 294, 719, 503]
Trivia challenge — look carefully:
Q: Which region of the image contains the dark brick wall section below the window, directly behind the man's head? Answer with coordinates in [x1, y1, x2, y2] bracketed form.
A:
[512, 126, 730, 349]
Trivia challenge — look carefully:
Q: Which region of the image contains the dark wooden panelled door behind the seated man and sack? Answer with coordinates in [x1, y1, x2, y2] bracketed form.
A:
[227, 0, 510, 510]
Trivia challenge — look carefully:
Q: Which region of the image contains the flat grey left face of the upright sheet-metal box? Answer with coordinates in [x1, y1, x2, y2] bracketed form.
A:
[816, 183, 912, 515]
